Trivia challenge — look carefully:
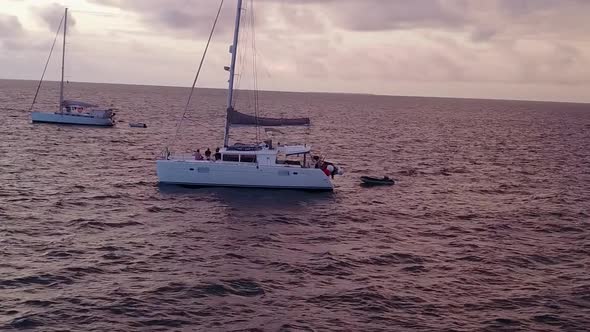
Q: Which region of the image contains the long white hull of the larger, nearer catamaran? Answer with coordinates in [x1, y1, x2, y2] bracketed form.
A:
[157, 160, 334, 191]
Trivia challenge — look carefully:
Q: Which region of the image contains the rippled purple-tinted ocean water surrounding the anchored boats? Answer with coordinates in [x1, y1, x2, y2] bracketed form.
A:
[0, 81, 590, 331]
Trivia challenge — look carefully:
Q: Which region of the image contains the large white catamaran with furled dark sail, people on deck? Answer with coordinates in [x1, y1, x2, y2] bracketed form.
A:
[157, 0, 343, 191]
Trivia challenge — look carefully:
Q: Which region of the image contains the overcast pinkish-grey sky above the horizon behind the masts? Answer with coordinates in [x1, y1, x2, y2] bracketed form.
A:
[0, 0, 590, 102]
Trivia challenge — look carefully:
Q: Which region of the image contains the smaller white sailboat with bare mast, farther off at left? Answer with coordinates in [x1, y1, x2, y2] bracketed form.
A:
[31, 8, 115, 127]
